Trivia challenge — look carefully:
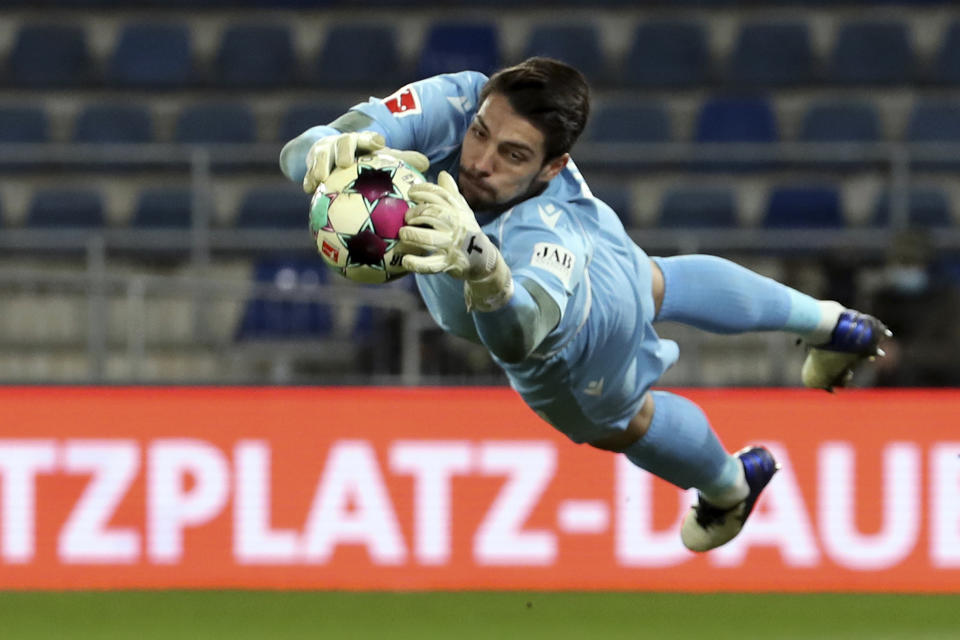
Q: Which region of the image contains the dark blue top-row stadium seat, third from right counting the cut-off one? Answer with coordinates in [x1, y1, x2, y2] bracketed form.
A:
[727, 22, 813, 86]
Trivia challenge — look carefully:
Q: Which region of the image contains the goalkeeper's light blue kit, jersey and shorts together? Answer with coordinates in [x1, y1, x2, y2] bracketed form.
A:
[284, 71, 678, 442]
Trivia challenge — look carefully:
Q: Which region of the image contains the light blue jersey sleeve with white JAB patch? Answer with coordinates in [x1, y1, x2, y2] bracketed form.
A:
[499, 198, 592, 315]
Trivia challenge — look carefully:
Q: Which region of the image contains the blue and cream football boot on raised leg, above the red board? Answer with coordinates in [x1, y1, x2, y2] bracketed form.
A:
[800, 309, 893, 391]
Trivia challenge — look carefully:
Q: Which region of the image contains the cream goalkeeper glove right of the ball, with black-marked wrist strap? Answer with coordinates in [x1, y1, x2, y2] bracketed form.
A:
[399, 171, 513, 311]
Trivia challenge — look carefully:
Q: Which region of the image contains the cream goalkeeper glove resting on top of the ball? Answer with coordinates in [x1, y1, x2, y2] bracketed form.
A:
[303, 131, 430, 193]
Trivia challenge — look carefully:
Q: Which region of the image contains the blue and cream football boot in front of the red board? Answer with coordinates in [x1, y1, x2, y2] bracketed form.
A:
[680, 447, 780, 551]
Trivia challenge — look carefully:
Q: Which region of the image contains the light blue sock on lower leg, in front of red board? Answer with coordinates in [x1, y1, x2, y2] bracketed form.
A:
[623, 391, 742, 499]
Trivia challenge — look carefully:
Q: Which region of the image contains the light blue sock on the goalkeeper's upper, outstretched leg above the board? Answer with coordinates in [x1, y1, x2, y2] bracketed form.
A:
[654, 255, 820, 337]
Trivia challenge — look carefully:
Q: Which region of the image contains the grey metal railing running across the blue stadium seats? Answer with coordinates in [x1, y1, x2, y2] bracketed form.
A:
[0, 143, 960, 384]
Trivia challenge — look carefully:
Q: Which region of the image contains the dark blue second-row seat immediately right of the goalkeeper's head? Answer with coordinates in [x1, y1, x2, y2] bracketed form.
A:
[584, 100, 672, 142]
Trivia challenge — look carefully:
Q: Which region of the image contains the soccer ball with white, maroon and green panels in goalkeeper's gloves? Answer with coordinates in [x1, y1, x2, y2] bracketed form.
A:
[310, 152, 425, 284]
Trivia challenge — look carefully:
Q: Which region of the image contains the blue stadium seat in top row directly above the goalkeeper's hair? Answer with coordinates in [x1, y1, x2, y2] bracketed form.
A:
[523, 23, 610, 84]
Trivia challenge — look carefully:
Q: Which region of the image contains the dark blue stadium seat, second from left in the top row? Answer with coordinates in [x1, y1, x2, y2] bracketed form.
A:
[107, 23, 194, 89]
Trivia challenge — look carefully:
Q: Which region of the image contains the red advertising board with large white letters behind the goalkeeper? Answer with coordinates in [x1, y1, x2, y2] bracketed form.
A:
[0, 388, 960, 592]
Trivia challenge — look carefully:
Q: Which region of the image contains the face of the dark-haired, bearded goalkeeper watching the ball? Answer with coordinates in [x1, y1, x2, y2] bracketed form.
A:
[457, 93, 569, 211]
